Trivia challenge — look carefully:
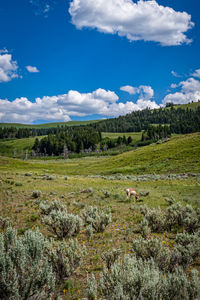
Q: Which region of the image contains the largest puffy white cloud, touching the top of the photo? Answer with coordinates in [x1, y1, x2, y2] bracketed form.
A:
[69, 0, 194, 46]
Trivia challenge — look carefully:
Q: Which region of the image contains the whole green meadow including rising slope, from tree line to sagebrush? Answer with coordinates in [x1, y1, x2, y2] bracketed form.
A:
[0, 133, 200, 300]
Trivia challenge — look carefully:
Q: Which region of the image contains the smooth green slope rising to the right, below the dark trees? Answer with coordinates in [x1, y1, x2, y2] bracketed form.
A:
[0, 133, 200, 175]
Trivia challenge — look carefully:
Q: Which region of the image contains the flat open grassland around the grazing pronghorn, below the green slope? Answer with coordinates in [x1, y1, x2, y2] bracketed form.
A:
[0, 164, 200, 299]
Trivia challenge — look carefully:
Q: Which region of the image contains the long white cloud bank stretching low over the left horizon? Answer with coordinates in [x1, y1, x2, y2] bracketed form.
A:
[0, 88, 159, 124]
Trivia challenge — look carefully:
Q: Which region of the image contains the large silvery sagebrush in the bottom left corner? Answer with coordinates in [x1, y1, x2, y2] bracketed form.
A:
[0, 227, 55, 300]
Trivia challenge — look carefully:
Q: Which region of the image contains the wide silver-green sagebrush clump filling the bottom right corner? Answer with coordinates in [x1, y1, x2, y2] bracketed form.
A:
[88, 255, 200, 300]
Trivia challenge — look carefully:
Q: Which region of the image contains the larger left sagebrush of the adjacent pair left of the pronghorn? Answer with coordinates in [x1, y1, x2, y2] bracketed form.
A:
[42, 210, 83, 239]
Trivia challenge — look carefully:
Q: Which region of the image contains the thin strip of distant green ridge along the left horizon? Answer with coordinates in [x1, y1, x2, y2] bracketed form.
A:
[0, 120, 99, 129]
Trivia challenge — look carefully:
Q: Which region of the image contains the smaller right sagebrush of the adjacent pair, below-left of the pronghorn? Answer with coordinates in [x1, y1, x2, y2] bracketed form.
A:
[82, 206, 111, 232]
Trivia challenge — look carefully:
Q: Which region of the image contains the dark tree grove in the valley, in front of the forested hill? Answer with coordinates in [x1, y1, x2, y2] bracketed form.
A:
[32, 126, 132, 157]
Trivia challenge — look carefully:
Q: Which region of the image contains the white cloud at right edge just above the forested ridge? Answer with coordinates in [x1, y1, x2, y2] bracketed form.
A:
[163, 77, 200, 104]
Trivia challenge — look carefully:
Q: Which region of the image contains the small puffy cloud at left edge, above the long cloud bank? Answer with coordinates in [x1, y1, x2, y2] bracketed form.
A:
[0, 49, 19, 82]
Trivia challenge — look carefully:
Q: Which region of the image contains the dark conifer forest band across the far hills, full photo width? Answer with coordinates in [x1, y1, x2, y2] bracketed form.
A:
[0, 105, 200, 139]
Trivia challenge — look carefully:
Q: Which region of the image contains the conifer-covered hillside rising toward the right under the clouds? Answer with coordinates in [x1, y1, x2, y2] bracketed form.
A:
[90, 105, 200, 133]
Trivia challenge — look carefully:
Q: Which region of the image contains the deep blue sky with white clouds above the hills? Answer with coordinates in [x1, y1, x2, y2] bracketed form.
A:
[0, 0, 200, 124]
